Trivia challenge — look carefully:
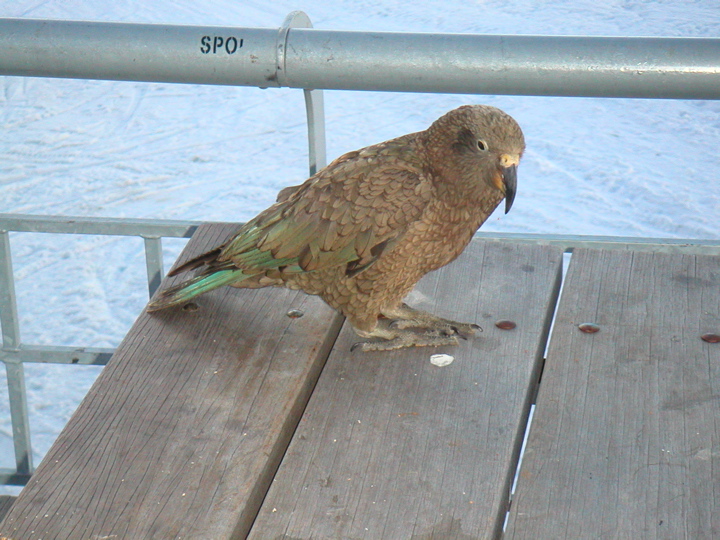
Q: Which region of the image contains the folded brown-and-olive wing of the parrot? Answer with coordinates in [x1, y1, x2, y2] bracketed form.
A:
[214, 143, 433, 274]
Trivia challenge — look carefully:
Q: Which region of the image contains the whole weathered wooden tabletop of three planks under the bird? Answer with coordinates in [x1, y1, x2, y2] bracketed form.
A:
[0, 224, 720, 540]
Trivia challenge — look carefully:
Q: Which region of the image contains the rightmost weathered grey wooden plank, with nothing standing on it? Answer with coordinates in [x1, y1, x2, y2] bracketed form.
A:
[506, 250, 720, 539]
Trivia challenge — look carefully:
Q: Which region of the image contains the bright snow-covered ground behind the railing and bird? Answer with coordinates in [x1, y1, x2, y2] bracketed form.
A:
[0, 0, 720, 493]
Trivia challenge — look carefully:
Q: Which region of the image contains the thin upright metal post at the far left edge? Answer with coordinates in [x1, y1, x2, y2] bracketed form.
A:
[0, 231, 33, 474]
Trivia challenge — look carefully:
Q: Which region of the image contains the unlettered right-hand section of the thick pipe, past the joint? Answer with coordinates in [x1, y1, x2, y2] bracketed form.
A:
[286, 30, 720, 99]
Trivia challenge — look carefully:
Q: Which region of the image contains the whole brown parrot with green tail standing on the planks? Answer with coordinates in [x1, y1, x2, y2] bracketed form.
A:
[148, 105, 525, 351]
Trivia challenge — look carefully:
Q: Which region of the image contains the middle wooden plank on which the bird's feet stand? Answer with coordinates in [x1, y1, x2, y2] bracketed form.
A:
[250, 241, 562, 540]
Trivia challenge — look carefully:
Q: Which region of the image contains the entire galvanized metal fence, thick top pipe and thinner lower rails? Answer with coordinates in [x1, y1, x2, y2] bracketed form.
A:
[0, 12, 720, 485]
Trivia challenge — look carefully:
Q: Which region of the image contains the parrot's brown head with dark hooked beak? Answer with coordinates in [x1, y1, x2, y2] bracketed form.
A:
[424, 105, 525, 214]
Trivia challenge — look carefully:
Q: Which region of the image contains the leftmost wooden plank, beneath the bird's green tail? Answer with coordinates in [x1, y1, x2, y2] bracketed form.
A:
[0, 221, 341, 540]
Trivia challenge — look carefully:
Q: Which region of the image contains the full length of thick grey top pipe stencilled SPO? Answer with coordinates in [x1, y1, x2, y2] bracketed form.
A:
[0, 19, 720, 99]
